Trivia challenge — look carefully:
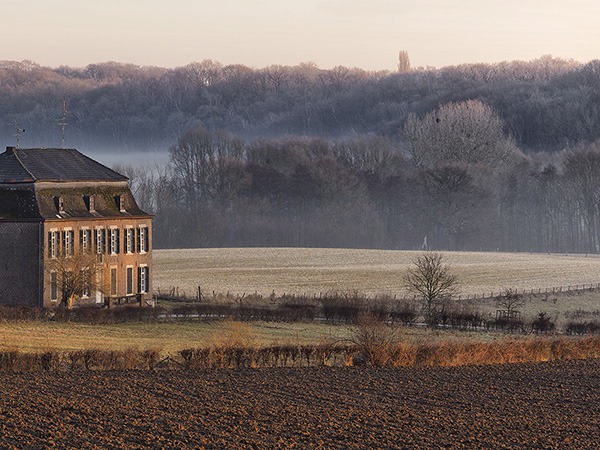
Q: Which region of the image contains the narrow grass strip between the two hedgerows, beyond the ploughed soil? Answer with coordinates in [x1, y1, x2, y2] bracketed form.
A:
[0, 322, 506, 353]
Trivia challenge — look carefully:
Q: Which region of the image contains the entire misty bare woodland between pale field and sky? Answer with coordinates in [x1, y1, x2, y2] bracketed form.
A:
[0, 56, 600, 253]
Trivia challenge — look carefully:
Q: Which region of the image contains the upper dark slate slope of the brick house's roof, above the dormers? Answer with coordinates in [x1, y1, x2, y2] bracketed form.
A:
[0, 147, 127, 183]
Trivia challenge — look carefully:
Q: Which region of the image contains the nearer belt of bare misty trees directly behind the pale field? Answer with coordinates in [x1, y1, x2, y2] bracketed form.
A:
[117, 113, 600, 253]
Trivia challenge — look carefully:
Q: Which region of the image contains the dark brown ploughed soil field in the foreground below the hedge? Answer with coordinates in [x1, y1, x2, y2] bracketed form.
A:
[0, 360, 600, 449]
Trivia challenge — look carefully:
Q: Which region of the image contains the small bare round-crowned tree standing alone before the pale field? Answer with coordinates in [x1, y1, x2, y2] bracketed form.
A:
[404, 253, 457, 325]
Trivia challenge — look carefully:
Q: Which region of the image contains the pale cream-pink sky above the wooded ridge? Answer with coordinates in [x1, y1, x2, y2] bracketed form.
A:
[0, 0, 600, 70]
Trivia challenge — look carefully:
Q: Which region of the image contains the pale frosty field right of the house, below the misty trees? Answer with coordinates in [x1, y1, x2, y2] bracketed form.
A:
[154, 248, 600, 297]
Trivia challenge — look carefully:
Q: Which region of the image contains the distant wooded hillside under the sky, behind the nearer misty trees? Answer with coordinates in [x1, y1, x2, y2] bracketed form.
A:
[0, 56, 600, 153]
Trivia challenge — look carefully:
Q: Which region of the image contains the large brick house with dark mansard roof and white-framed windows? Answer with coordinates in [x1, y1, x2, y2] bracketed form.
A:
[0, 147, 152, 308]
